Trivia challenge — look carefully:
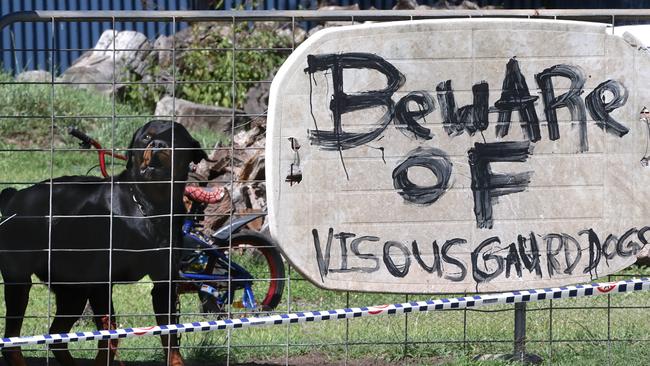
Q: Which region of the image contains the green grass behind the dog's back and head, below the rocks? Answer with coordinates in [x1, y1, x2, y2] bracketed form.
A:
[0, 73, 227, 189]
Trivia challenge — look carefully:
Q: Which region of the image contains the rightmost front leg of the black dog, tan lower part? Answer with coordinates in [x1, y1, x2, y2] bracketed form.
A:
[151, 283, 184, 366]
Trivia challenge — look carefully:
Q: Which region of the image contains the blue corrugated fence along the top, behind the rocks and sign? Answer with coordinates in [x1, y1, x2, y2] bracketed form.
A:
[0, 0, 650, 74]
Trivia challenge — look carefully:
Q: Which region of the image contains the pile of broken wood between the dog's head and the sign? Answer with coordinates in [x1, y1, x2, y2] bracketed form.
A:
[195, 118, 266, 233]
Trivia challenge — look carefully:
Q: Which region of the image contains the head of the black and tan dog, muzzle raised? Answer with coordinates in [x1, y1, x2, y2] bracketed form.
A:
[126, 120, 207, 181]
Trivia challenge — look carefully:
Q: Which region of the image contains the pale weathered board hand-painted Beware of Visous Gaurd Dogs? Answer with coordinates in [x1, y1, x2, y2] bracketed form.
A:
[267, 19, 650, 293]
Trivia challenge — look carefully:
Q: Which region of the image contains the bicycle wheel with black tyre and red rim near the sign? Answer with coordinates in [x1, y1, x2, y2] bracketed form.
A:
[199, 230, 285, 313]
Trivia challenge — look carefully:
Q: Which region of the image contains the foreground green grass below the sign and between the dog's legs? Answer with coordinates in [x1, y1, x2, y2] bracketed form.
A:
[0, 267, 650, 365]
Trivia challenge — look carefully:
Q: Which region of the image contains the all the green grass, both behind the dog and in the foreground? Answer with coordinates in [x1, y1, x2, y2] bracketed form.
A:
[0, 75, 650, 366]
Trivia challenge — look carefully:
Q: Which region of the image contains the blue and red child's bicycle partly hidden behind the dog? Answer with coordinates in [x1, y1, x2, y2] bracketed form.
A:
[69, 128, 285, 314]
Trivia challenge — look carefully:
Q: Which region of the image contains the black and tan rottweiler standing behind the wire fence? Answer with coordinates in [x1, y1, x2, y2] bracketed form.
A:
[0, 120, 206, 366]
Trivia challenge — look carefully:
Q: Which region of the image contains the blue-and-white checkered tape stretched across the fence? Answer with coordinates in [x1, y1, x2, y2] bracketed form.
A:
[0, 278, 650, 348]
